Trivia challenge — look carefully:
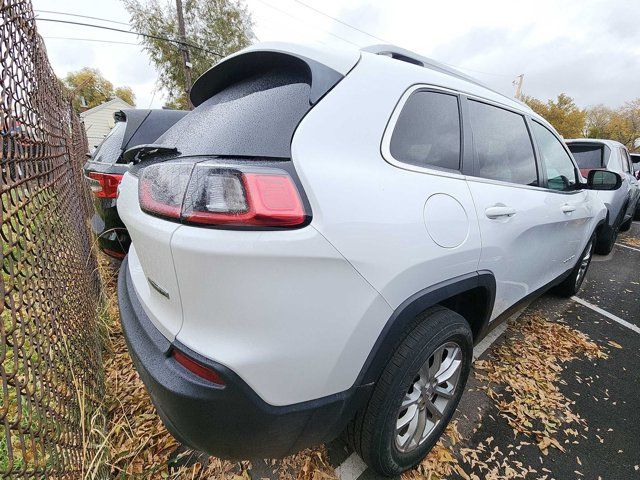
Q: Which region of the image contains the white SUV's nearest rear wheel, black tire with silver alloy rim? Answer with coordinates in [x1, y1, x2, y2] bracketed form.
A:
[347, 306, 473, 476]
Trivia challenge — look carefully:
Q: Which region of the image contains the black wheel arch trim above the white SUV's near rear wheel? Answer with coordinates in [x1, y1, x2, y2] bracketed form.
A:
[356, 271, 496, 385]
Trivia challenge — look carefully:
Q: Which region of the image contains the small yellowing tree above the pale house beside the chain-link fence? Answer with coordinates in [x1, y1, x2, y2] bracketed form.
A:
[62, 67, 135, 112]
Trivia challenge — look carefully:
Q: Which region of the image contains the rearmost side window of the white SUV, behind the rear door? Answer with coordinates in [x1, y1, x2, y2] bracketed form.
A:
[389, 91, 460, 170]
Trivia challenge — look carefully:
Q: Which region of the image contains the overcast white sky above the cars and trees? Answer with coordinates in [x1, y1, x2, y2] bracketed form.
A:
[33, 0, 640, 108]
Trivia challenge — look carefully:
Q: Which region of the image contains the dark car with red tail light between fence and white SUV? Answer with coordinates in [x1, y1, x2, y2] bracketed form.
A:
[84, 109, 188, 258]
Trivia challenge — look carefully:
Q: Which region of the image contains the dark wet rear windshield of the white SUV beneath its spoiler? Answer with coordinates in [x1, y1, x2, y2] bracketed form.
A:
[156, 70, 311, 158]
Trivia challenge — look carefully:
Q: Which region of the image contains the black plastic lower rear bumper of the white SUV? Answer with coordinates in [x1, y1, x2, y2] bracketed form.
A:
[118, 259, 370, 459]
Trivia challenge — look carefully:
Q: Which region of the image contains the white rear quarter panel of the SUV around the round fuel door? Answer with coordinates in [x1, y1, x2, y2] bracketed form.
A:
[292, 53, 480, 308]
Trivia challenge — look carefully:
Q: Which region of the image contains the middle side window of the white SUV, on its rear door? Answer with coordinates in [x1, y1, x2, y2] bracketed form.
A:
[469, 100, 538, 186]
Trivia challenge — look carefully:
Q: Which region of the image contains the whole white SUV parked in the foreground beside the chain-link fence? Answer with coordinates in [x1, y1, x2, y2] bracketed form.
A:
[118, 44, 620, 475]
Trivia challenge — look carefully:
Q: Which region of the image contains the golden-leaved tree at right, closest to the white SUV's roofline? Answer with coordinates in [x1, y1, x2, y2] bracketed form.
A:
[523, 93, 587, 138]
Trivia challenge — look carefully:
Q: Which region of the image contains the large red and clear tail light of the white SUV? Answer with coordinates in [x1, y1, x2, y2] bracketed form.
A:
[139, 163, 307, 227]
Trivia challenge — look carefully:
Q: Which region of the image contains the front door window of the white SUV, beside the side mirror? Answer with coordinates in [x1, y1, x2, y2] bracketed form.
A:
[533, 122, 577, 191]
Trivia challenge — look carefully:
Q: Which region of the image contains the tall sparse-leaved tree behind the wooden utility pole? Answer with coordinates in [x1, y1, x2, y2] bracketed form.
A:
[122, 0, 253, 108]
